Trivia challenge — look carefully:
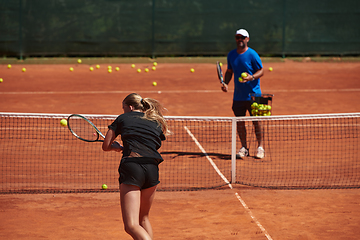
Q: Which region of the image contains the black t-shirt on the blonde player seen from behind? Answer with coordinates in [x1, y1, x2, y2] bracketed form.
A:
[109, 112, 166, 163]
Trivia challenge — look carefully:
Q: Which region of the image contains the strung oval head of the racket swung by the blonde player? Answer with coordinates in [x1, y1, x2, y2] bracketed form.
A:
[67, 114, 105, 142]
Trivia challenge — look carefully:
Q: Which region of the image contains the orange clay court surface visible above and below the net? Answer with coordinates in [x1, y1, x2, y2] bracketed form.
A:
[0, 59, 360, 240]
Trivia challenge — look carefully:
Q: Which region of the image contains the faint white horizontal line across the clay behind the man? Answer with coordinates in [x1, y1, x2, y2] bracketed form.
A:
[0, 88, 360, 95]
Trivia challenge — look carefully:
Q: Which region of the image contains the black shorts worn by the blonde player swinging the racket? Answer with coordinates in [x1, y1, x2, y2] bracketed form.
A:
[119, 160, 160, 189]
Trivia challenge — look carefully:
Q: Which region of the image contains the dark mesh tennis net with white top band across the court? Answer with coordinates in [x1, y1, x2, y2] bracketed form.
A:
[0, 113, 360, 194]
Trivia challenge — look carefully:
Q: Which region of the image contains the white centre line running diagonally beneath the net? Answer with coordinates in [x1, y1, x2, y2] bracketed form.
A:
[184, 126, 273, 240]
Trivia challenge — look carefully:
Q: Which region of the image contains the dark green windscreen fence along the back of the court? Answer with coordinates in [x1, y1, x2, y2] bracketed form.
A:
[0, 0, 360, 57]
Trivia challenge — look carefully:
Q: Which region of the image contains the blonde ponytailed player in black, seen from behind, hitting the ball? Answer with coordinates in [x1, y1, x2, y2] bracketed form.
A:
[102, 93, 169, 239]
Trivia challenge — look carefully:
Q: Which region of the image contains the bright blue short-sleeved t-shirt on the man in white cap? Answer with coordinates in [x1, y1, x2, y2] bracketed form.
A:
[227, 48, 263, 101]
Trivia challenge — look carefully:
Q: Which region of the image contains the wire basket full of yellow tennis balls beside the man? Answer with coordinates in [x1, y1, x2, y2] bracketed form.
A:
[250, 93, 274, 116]
